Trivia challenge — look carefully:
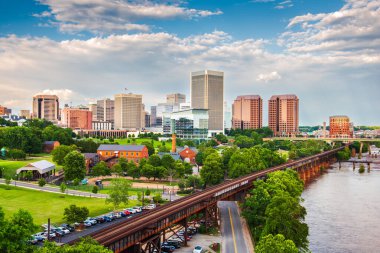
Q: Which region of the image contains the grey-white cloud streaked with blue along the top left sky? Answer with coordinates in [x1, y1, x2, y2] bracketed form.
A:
[34, 0, 222, 34]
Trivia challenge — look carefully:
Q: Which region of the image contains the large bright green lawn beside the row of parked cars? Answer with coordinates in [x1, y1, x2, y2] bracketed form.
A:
[0, 185, 137, 225]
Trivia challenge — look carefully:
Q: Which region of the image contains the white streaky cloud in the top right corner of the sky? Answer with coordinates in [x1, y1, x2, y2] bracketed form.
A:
[279, 0, 380, 52]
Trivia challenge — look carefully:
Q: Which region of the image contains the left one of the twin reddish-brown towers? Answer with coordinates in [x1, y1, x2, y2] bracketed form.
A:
[232, 95, 263, 130]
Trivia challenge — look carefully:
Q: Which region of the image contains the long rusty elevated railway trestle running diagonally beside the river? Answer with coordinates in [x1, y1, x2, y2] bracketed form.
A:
[69, 147, 344, 253]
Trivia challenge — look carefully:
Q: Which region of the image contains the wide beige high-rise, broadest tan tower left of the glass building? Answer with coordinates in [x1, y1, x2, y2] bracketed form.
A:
[115, 93, 143, 130]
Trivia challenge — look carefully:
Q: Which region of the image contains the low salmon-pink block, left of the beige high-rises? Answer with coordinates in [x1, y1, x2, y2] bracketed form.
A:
[61, 107, 92, 129]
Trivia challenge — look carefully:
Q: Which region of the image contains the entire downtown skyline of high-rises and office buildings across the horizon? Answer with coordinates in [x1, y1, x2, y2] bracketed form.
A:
[0, 70, 353, 139]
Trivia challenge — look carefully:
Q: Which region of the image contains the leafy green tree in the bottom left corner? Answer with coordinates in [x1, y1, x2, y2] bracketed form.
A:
[0, 207, 37, 253]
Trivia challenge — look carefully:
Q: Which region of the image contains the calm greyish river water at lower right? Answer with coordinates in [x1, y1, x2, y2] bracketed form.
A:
[302, 163, 380, 253]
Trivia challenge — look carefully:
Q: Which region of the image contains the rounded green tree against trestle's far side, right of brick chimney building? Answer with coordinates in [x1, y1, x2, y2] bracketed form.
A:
[200, 153, 224, 185]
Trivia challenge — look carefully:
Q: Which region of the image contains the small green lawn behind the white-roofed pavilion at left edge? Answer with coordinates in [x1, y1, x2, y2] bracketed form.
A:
[0, 154, 62, 177]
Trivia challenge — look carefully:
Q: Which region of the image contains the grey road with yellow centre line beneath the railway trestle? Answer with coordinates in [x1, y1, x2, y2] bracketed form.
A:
[218, 201, 250, 253]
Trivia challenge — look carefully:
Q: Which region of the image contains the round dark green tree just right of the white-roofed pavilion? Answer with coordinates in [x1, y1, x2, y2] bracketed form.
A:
[63, 151, 86, 180]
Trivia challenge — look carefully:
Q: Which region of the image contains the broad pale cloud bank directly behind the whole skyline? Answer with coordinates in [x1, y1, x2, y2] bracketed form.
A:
[0, 31, 380, 124]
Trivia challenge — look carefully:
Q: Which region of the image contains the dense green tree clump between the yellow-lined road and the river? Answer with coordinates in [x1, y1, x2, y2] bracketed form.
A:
[243, 169, 309, 253]
